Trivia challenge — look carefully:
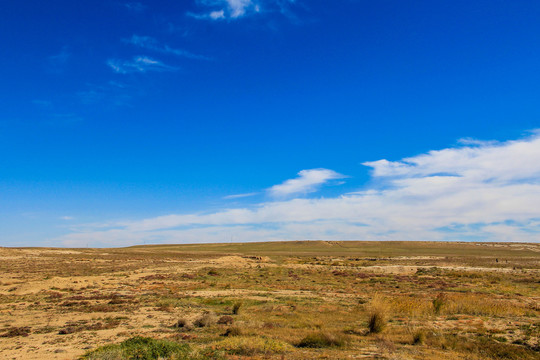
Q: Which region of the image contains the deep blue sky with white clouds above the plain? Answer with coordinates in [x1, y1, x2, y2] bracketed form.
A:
[0, 0, 540, 246]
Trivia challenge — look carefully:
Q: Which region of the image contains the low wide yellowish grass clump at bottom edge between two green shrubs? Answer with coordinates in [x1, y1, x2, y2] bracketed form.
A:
[214, 336, 293, 356]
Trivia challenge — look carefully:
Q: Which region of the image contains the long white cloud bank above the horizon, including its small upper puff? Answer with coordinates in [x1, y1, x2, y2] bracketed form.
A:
[58, 133, 540, 246]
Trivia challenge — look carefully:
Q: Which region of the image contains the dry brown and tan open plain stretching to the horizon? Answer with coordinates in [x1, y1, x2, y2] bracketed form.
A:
[0, 241, 540, 359]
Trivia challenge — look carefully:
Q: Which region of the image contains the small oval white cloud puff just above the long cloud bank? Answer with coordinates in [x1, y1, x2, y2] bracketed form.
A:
[268, 169, 344, 197]
